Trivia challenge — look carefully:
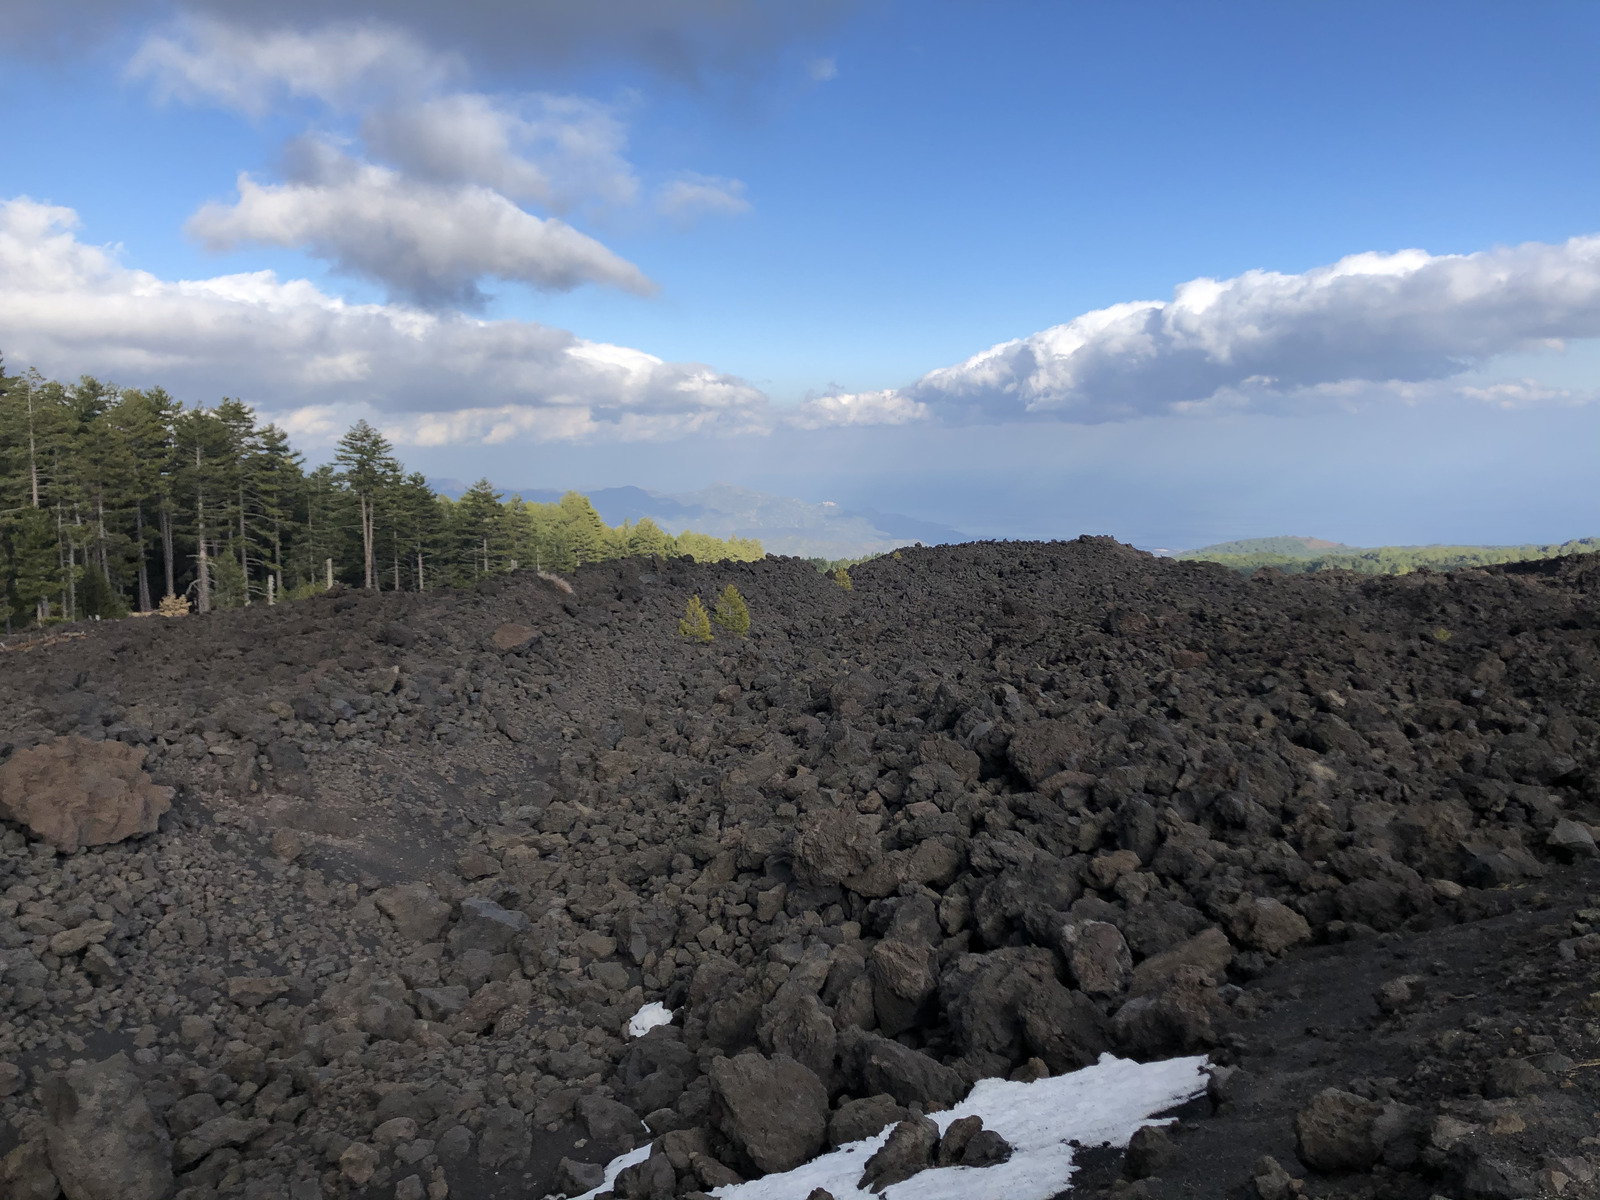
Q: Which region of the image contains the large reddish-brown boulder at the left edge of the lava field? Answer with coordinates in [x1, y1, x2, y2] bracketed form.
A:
[0, 736, 173, 854]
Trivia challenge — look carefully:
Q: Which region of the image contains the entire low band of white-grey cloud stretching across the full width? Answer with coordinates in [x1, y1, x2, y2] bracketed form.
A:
[0, 200, 1600, 445]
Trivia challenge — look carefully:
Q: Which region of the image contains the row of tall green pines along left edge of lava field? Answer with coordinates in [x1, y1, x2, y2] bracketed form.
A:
[0, 360, 763, 629]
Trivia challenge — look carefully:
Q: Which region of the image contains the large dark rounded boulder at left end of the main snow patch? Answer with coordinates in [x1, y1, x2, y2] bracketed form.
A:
[710, 1054, 827, 1171]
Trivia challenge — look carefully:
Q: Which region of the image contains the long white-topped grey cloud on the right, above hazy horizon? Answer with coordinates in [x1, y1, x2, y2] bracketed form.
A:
[851, 237, 1600, 422]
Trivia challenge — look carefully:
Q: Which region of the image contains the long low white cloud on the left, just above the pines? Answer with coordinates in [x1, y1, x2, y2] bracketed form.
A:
[0, 198, 773, 445]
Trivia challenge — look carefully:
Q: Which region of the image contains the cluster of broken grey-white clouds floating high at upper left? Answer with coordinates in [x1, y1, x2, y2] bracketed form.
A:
[128, 13, 749, 307]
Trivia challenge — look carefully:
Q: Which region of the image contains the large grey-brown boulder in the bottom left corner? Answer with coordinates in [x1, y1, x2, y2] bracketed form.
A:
[45, 1054, 173, 1200]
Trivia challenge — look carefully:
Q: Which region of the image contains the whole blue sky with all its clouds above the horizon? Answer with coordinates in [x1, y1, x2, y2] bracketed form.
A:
[0, 0, 1600, 546]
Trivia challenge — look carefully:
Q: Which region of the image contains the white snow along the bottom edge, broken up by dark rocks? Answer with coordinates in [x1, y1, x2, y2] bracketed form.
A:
[578, 1056, 1208, 1200]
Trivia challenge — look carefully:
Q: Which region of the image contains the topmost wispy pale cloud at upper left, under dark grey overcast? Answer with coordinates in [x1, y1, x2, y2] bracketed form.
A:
[128, 18, 461, 115]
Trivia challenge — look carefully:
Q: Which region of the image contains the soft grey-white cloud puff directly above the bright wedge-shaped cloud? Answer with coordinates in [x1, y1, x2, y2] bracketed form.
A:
[362, 93, 638, 211]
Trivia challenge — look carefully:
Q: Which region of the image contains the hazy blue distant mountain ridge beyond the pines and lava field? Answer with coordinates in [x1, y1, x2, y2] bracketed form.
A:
[429, 480, 968, 560]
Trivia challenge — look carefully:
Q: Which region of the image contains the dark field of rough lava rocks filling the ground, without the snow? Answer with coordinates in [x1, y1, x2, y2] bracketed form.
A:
[0, 539, 1600, 1200]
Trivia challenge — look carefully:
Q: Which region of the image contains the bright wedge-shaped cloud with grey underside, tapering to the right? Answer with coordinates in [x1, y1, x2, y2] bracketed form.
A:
[187, 139, 654, 306]
